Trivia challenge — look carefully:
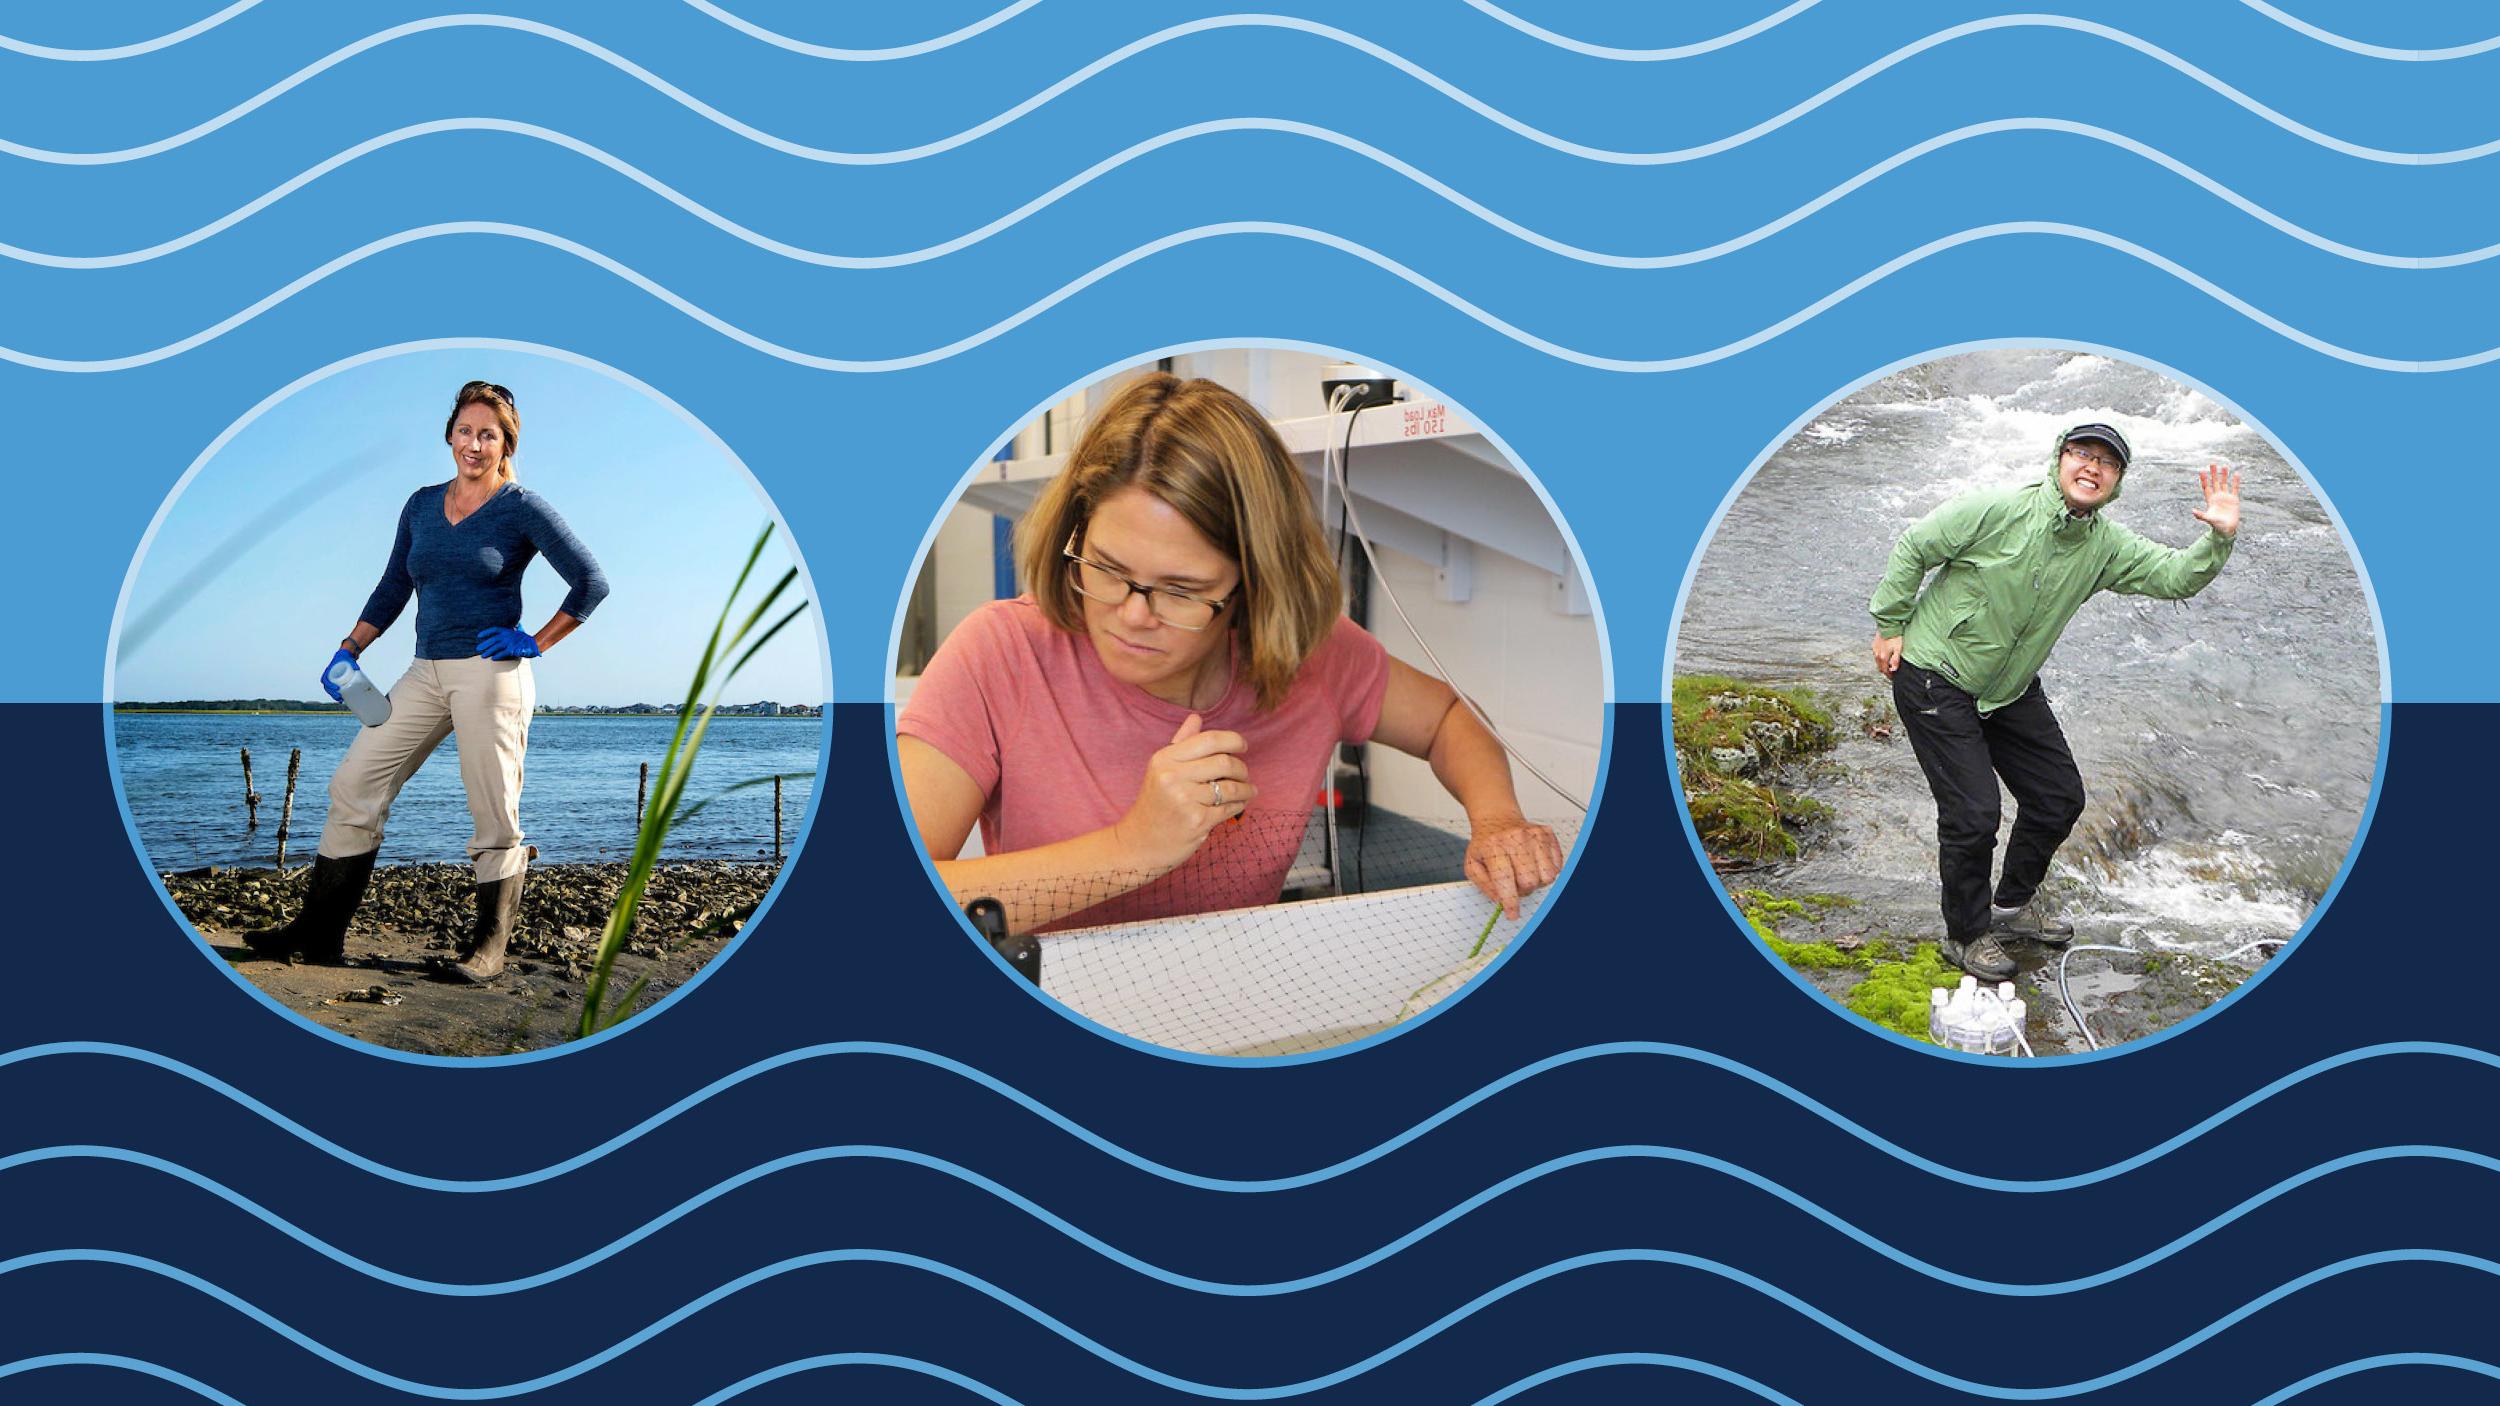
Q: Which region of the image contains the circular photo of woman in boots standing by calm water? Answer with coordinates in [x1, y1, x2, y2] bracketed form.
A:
[105, 343, 830, 1063]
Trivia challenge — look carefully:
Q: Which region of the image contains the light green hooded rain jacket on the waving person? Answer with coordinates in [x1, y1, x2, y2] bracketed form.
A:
[1868, 463, 2233, 713]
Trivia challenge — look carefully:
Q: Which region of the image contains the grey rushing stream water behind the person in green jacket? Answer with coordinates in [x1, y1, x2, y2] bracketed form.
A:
[1675, 350, 2380, 948]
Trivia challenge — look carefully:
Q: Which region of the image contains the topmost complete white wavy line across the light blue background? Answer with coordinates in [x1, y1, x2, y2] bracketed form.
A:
[0, 15, 2500, 165]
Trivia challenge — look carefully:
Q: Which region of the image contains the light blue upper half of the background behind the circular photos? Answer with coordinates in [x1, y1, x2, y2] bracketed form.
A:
[0, 3, 2500, 700]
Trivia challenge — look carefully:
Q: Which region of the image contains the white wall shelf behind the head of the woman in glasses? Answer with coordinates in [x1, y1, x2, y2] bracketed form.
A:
[963, 400, 1588, 595]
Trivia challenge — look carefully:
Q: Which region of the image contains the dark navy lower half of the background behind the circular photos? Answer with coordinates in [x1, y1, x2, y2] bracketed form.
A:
[0, 706, 2500, 1403]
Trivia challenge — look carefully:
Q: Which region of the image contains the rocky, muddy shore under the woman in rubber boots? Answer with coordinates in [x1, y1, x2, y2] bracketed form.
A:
[163, 861, 780, 1056]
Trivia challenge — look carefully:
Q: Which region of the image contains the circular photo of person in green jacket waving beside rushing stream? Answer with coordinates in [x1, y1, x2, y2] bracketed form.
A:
[1668, 345, 2388, 1058]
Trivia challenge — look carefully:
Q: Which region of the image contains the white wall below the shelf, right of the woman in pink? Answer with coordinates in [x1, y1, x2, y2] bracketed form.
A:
[1370, 535, 1605, 821]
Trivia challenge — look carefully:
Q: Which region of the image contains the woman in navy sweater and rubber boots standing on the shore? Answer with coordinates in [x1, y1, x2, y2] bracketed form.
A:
[245, 380, 608, 981]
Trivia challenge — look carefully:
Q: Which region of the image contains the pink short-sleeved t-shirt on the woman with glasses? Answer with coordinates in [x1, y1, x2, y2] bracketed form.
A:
[895, 595, 1390, 931]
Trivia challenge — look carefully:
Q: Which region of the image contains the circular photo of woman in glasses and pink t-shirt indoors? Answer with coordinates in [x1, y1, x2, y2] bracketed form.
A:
[893, 345, 1608, 1058]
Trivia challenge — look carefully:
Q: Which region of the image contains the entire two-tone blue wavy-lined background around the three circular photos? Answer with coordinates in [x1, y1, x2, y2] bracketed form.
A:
[0, 0, 2500, 1406]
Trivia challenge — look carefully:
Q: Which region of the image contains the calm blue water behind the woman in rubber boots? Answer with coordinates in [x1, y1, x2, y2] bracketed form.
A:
[113, 713, 825, 868]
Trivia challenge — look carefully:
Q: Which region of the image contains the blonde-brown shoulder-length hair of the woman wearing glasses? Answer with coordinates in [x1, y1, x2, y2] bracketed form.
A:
[1015, 373, 1340, 711]
